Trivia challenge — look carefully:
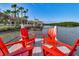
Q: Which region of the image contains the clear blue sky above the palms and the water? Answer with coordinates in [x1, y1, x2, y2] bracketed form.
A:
[0, 3, 79, 23]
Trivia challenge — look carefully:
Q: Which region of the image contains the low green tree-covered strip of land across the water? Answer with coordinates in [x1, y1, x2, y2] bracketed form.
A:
[44, 22, 79, 27]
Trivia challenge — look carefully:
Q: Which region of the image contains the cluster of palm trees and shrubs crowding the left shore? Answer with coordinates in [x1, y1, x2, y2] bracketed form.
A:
[0, 4, 28, 31]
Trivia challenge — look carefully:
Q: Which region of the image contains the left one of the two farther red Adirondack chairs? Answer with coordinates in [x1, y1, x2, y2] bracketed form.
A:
[20, 27, 36, 44]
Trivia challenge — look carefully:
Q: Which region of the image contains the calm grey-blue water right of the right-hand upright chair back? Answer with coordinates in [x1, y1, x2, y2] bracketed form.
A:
[57, 27, 79, 45]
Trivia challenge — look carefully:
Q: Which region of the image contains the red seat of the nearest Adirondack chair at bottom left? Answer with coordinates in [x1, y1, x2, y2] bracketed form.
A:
[7, 45, 33, 56]
